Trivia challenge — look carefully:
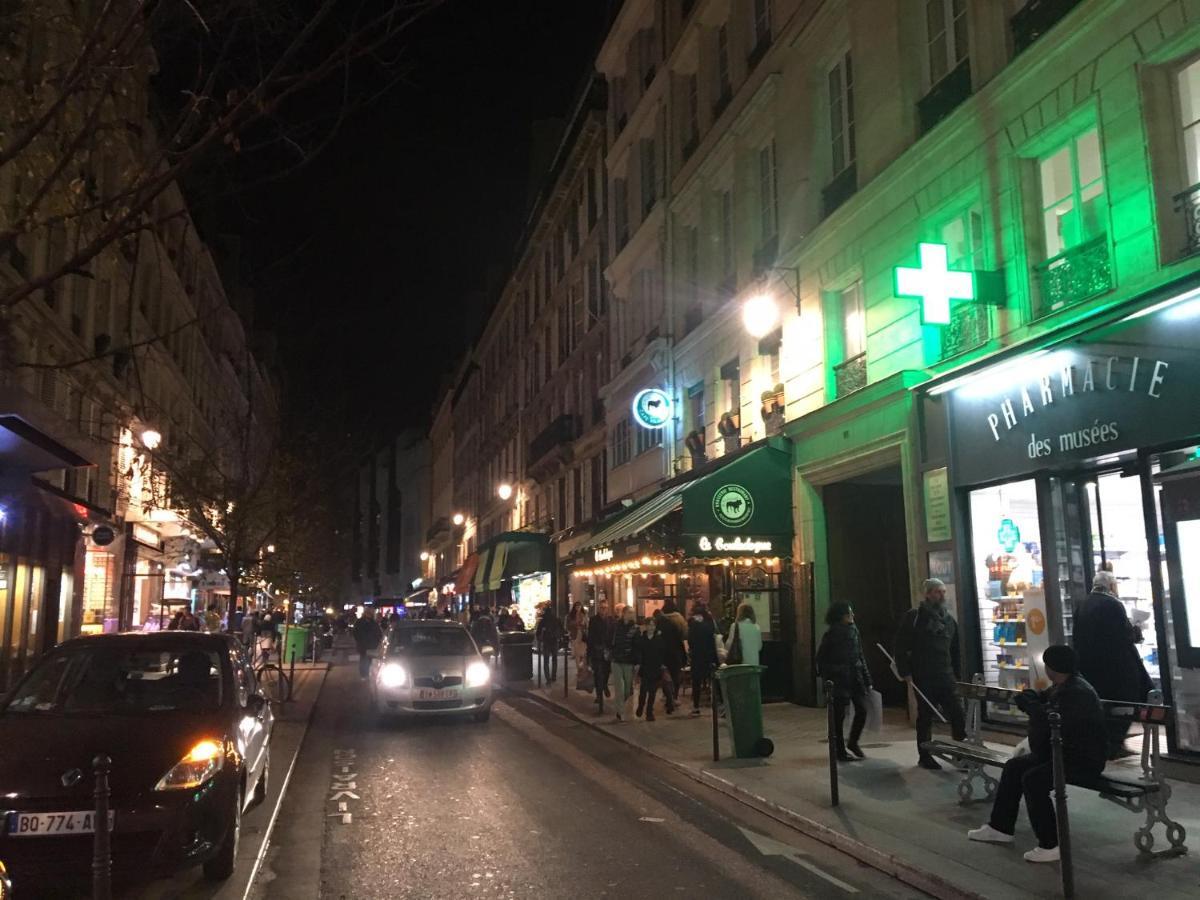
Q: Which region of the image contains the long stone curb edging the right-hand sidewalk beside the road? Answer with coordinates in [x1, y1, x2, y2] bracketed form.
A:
[504, 685, 986, 900]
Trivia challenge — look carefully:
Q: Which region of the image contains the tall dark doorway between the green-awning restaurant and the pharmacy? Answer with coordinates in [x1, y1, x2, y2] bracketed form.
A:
[816, 466, 912, 706]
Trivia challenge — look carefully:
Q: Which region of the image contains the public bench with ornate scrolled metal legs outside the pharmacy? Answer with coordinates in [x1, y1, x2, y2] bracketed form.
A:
[922, 674, 1187, 856]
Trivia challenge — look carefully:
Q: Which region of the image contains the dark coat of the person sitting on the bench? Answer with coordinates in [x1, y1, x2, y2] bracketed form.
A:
[1018, 676, 1109, 778]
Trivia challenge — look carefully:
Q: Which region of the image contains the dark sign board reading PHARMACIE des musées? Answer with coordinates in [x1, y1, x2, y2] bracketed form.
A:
[934, 286, 1200, 484]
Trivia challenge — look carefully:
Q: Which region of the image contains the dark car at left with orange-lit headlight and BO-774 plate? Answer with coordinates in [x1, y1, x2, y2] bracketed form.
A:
[0, 631, 274, 896]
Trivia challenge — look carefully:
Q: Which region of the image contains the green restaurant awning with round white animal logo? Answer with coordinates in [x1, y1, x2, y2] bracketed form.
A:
[578, 439, 792, 562]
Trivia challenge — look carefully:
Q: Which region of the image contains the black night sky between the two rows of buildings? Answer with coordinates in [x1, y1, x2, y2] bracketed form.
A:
[201, 0, 612, 439]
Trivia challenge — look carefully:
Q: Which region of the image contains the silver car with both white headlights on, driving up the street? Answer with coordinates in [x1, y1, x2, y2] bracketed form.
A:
[371, 619, 492, 722]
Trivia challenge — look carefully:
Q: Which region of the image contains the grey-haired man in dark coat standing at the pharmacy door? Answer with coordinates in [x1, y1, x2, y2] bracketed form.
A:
[1072, 572, 1154, 760]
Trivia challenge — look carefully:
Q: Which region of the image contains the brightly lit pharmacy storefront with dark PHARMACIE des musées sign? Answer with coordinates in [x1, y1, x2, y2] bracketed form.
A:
[920, 283, 1200, 752]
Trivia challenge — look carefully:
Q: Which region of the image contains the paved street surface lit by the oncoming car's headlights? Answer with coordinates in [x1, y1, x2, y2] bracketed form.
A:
[252, 665, 916, 900]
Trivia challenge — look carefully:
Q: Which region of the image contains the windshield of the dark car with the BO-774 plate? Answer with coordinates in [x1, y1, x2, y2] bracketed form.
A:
[2, 647, 223, 716]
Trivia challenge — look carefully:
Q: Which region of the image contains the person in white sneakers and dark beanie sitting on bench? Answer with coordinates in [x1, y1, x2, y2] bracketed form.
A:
[967, 644, 1108, 863]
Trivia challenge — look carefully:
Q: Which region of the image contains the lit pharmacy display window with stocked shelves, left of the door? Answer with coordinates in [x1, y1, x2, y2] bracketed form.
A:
[970, 480, 1049, 721]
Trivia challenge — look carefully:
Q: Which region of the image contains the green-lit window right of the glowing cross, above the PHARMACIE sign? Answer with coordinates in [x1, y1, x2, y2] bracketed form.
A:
[1038, 127, 1108, 258]
